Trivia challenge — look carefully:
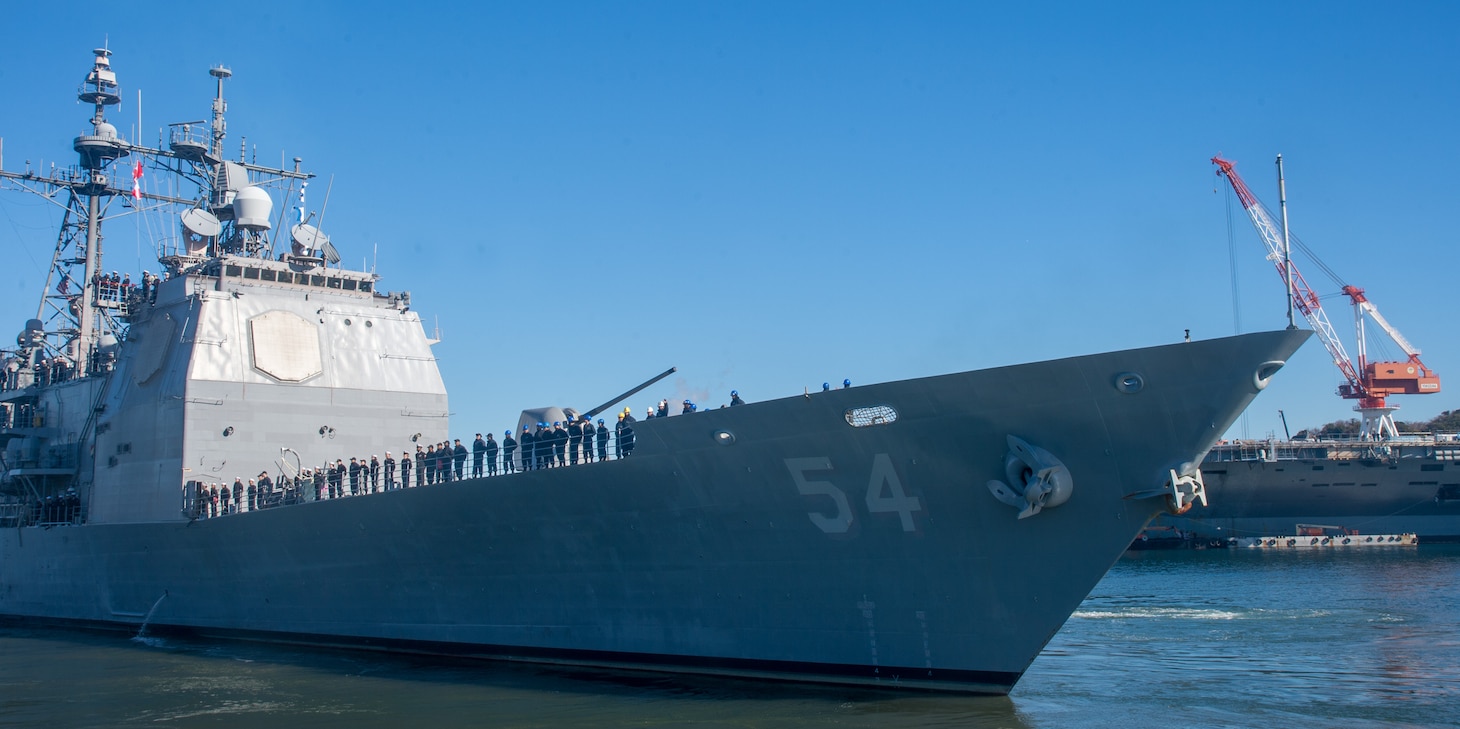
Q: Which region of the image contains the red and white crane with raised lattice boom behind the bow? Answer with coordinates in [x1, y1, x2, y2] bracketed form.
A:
[1212, 155, 1440, 438]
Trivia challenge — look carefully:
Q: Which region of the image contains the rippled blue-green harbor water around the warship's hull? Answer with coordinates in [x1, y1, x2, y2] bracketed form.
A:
[0, 545, 1460, 729]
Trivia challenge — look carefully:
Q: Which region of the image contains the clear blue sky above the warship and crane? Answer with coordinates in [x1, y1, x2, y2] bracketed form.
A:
[0, 1, 1460, 437]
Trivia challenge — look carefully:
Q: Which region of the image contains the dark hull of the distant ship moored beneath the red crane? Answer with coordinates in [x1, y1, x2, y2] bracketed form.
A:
[1156, 443, 1460, 543]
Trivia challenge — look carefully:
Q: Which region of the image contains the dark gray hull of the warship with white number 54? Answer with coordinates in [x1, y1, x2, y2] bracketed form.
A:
[0, 332, 1307, 694]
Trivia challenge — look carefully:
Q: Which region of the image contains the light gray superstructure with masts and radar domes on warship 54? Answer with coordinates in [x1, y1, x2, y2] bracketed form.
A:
[0, 48, 447, 523]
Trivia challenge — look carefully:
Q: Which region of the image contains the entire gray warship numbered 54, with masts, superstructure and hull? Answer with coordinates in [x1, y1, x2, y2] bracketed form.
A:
[0, 50, 1308, 694]
